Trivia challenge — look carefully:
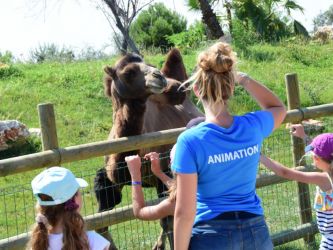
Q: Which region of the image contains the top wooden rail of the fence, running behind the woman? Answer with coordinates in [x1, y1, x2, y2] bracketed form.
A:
[0, 103, 333, 177]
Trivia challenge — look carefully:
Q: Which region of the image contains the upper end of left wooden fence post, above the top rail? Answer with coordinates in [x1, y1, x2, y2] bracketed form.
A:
[38, 103, 59, 151]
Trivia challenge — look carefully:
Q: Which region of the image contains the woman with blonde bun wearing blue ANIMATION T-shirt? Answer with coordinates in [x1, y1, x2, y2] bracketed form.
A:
[172, 42, 286, 250]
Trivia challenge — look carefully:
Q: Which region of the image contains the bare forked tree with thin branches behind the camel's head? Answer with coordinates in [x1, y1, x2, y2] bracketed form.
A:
[100, 0, 154, 54]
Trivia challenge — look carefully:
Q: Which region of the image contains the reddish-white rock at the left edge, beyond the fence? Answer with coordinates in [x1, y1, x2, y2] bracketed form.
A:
[0, 120, 30, 151]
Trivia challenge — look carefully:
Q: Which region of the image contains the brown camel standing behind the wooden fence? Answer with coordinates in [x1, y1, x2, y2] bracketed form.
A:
[95, 49, 203, 249]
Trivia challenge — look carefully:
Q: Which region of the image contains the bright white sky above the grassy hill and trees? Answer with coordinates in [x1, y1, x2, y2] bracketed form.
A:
[0, 0, 333, 60]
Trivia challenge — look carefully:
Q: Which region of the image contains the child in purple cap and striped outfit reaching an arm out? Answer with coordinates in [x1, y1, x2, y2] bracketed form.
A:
[260, 125, 333, 250]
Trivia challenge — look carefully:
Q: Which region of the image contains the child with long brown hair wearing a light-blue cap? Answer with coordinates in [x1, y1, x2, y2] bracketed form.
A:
[28, 167, 110, 250]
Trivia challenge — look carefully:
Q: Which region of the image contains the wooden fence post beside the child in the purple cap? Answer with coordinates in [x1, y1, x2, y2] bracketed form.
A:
[285, 74, 315, 246]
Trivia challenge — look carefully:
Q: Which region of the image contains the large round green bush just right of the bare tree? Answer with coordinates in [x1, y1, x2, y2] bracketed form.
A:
[130, 3, 186, 50]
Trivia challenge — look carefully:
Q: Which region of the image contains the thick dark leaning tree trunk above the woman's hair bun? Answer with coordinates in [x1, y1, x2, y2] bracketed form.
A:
[198, 0, 224, 39]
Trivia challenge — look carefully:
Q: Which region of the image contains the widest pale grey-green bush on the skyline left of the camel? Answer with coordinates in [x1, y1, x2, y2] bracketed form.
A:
[30, 43, 75, 63]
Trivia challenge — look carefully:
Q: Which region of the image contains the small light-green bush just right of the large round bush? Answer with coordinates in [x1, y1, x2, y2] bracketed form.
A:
[167, 21, 207, 52]
